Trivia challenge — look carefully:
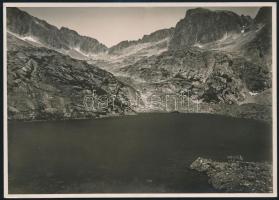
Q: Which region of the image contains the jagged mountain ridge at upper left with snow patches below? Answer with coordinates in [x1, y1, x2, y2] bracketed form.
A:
[7, 7, 107, 54]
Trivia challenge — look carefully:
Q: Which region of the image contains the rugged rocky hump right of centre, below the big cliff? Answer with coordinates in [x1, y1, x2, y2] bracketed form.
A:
[121, 47, 271, 104]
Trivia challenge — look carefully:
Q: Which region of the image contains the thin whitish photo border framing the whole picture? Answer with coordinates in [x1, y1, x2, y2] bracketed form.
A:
[3, 2, 277, 198]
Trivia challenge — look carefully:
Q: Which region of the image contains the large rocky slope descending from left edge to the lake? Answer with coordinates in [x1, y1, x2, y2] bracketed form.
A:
[7, 34, 141, 120]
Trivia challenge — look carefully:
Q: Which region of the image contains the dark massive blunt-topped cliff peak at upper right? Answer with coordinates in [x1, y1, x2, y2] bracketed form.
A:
[170, 8, 253, 49]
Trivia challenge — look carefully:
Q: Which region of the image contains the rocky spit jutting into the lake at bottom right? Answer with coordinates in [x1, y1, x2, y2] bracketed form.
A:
[190, 157, 272, 193]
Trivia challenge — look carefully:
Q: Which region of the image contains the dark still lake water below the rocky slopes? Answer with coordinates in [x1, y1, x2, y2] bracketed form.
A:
[8, 113, 272, 194]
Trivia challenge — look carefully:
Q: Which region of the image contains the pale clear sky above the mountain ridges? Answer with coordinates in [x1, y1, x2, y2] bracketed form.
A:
[20, 7, 259, 47]
